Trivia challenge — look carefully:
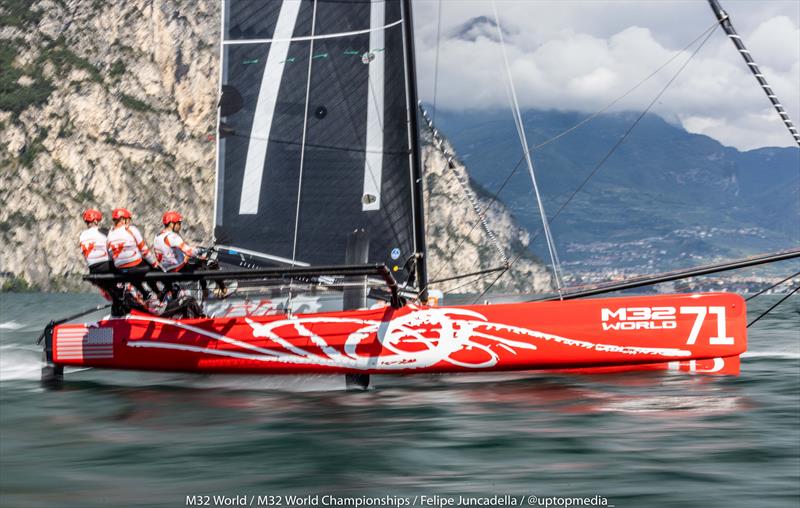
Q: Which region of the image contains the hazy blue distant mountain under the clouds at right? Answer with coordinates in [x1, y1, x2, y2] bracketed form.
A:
[437, 111, 800, 280]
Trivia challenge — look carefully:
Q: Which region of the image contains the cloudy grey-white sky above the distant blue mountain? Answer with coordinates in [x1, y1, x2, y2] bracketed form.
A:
[414, 0, 800, 150]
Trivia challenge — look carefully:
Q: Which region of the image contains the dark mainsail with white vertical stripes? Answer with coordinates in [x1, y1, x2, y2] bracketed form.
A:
[214, 0, 424, 285]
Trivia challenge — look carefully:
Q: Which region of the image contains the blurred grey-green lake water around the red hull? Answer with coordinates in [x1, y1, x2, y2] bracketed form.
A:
[0, 294, 800, 508]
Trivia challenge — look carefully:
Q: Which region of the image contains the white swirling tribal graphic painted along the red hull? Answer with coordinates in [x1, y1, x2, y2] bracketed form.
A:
[120, 307, 691, 371]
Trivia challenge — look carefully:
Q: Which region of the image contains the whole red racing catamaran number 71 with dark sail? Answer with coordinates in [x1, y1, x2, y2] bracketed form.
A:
[43, 0, 800, 387]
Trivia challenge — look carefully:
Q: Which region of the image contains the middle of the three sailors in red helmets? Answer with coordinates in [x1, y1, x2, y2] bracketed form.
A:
[108, 208, 160, 299]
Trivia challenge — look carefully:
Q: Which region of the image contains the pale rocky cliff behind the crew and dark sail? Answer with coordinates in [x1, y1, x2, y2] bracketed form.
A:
[0, 0, 550, 298]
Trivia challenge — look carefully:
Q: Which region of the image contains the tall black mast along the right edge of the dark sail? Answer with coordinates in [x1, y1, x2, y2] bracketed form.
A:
[401, 0, 428, 302]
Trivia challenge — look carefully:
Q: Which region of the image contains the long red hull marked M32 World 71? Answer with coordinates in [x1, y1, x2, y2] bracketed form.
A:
[53, 293, 746, 374]
